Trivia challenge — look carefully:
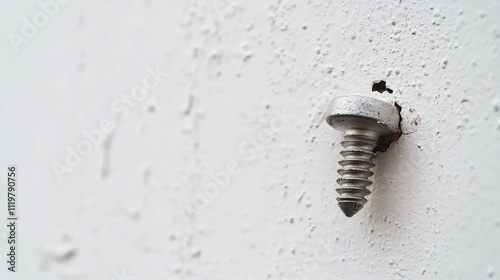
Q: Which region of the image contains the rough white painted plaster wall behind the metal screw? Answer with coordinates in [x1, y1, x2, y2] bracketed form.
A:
[0, 0, 500, 280]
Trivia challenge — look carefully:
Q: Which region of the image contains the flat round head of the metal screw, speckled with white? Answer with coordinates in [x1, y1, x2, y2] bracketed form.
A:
[326, 95, 399, 135]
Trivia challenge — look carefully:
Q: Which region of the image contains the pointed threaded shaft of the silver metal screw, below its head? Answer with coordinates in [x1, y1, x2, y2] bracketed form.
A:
[336, 129, 378, 217]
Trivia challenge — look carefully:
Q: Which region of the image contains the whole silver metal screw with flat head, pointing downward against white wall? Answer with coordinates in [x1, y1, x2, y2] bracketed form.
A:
[326, 95, 399, 217]
